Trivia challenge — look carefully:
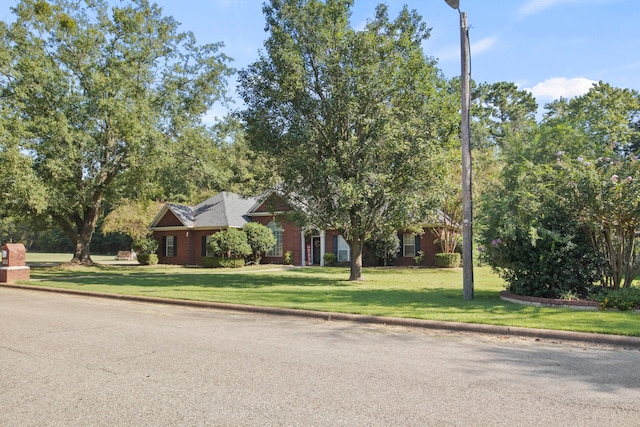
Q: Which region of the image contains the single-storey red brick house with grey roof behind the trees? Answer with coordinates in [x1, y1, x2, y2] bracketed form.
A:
[150, 192, 438, 266]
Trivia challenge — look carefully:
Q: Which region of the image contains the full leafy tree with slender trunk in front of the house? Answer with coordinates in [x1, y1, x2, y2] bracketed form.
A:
[240, 0, 456, 280]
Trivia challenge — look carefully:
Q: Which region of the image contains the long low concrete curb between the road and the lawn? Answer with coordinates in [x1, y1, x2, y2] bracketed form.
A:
[5, 283, 640, 349]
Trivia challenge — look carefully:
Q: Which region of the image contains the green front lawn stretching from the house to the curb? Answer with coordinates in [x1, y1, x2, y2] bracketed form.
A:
[15, 258, 640, 336]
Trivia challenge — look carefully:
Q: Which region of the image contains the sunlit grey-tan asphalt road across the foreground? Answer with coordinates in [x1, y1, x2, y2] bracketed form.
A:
[0, 288, 640, 426]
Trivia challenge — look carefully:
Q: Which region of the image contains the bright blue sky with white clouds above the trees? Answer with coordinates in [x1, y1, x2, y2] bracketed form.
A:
[0, 0, 640, 123]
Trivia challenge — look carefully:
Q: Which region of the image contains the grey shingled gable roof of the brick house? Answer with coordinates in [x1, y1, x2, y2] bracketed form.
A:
[149, 191, 258, 229]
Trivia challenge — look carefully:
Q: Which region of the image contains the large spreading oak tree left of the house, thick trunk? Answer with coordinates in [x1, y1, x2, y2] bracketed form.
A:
[0, 0, 231, 263]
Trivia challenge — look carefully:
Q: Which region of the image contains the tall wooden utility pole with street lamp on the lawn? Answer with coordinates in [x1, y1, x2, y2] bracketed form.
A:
[445, 0, 473, 300]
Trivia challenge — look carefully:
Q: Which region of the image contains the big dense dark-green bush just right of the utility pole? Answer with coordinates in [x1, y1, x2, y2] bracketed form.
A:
[479, 147, 603, 298]
